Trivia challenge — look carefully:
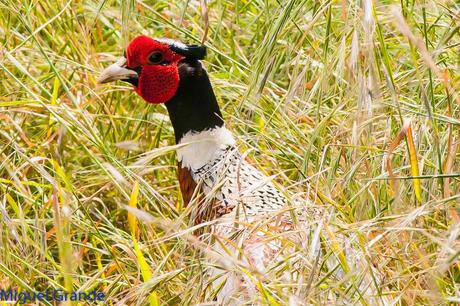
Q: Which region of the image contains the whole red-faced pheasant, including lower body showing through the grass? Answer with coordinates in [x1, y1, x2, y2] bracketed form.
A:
[98, 36, 384, 304]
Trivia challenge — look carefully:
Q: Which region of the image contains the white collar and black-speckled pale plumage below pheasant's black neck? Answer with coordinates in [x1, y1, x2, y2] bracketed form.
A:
[178, 127, 286, 222]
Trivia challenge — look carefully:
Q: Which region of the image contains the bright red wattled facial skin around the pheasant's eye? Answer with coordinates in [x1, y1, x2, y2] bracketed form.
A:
[126, 36, 184, 103]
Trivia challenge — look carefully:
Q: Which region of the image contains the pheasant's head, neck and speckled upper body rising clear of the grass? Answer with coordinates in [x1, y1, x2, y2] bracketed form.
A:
[98, 36, 296, 298]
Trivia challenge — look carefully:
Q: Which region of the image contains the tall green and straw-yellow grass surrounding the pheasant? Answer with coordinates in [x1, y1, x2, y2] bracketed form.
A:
[0, 0, 460, 305]
